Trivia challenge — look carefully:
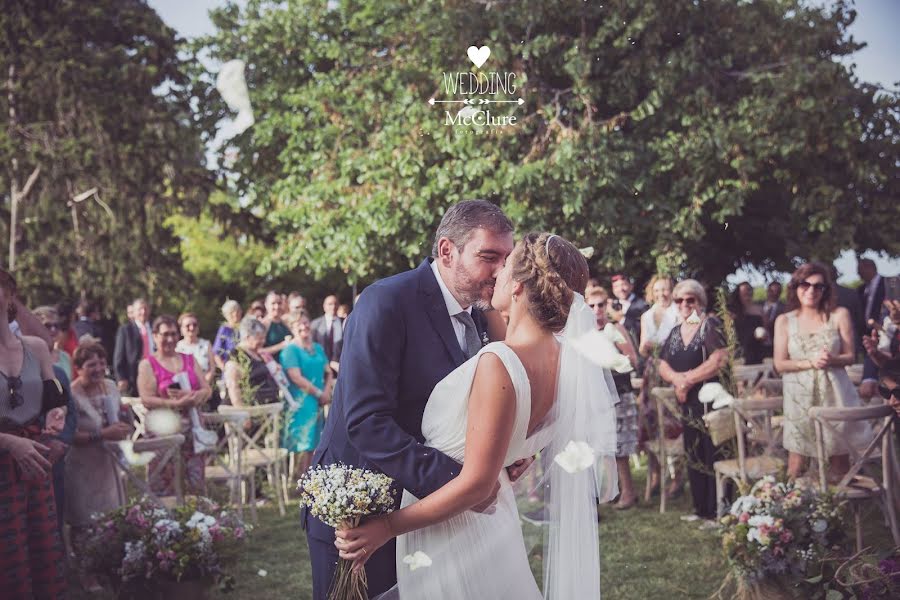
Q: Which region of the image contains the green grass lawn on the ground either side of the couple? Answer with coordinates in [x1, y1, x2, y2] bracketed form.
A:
[73, 471, 892, 600]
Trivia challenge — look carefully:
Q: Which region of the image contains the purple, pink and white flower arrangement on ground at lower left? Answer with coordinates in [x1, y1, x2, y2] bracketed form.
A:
[81, 498, 248, 595]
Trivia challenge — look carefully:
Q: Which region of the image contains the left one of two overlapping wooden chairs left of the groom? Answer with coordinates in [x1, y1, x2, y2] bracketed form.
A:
[202, 411, 259, 523]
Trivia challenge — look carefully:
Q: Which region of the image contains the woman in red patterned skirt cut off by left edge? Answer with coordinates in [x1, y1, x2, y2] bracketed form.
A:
[0, 269, 66, 598]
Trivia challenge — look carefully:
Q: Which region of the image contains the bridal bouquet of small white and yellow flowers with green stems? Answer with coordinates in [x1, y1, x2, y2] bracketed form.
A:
[297, 463, 395, 600]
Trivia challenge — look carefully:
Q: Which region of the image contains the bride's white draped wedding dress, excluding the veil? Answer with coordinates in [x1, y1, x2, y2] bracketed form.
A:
[397, 342, 549, 600]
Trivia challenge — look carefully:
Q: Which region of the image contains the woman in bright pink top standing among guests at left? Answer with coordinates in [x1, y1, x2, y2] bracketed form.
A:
[137, 315, 212, 496]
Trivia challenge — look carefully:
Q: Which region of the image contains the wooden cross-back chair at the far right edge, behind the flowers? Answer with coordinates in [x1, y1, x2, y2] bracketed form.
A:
[809, 404, 900, 551]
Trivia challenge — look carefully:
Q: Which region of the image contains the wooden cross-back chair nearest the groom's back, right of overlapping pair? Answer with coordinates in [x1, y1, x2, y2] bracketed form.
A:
[218, 402, 288, 516]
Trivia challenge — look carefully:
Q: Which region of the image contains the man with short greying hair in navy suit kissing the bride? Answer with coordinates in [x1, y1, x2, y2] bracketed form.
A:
[301, 200, 513, 600]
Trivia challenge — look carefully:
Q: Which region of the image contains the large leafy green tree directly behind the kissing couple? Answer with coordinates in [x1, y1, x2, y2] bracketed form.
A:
[197, 0, 900, 282]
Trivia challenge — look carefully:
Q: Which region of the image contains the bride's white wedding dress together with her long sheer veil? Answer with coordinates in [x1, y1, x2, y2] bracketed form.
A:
[378, 294, 618, 600]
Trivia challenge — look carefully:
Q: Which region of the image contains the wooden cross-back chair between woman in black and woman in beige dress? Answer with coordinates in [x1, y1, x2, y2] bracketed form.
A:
[713, 397, 784, 517]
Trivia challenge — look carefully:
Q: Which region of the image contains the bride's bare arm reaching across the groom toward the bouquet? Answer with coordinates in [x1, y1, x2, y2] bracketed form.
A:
[335, 352, 516, 565]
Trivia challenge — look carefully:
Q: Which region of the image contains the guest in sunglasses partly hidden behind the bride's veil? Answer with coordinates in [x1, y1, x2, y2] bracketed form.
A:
[584, 288, 638, 510]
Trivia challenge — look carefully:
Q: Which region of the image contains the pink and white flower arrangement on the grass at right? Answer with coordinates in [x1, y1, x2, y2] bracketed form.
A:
[720, 477, 845, 598]
